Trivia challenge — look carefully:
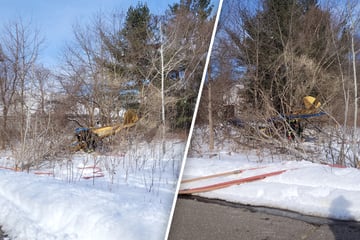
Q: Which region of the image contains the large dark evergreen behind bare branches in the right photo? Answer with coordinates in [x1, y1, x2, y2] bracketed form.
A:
[224, 0, 348, 112]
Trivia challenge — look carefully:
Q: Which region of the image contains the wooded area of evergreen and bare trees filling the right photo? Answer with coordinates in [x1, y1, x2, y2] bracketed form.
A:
[197, 0, 360, 165]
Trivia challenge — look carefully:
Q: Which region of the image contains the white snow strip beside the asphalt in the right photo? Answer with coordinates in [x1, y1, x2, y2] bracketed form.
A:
[180, 150, 360, 221]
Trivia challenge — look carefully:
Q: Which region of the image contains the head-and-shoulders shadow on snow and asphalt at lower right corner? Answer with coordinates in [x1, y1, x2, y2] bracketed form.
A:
[329, 196, 360, 240]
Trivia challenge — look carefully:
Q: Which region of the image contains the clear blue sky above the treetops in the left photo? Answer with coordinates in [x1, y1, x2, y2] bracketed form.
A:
[0, 0, 210, 66]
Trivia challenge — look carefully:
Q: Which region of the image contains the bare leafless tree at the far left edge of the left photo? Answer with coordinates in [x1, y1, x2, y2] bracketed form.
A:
[0, 19, 42, 148]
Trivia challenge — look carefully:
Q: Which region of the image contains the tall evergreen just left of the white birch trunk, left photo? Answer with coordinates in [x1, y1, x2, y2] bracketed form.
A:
[100, 3, 153, 82]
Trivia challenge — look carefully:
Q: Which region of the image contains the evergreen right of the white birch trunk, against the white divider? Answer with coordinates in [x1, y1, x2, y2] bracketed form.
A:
[165, 0, 214, 128]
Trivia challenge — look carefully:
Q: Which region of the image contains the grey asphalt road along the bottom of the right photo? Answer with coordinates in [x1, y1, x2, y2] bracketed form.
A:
[168, 198, 360, 240]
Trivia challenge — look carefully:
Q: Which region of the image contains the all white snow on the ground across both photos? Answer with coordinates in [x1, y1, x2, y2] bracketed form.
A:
[0, 122, 360, 240]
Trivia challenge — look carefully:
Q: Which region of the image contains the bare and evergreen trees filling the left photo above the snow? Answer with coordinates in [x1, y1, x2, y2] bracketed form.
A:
[0, 0, 214, 169]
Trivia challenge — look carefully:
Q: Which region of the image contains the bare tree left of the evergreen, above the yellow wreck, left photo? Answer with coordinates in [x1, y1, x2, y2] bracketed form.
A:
[59, 14, 126, 126]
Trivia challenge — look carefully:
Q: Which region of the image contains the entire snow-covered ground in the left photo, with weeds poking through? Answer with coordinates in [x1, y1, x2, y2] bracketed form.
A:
[0, 141, 185, 240]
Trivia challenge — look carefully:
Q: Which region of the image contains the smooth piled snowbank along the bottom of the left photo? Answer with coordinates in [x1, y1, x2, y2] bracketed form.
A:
[0, 170, 167, 239]
